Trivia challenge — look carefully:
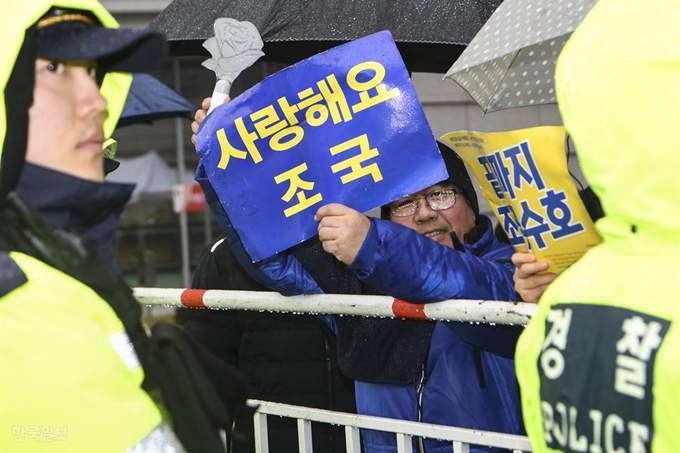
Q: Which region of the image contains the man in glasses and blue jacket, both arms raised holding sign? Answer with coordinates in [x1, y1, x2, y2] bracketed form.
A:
[192, 103, 523, 453]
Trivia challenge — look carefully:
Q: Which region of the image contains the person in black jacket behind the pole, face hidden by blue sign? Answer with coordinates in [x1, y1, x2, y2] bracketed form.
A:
[180, 240, 356, 453]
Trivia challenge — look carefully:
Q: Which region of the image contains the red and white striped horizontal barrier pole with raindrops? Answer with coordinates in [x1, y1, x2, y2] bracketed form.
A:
[134, 288, 536, 325]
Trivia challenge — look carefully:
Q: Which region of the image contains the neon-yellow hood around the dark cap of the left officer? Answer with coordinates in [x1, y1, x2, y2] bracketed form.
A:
[0, 0, 132, 205]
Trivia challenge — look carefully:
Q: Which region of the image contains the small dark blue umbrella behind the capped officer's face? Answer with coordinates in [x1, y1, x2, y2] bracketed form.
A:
[117, 73, 198, 127]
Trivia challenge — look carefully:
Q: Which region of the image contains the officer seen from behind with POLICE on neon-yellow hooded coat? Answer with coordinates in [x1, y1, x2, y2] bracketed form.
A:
[516, 0, 680, 453]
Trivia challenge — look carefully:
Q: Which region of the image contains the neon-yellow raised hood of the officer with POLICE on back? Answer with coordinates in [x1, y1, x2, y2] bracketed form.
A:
[555, 0, 680, 239]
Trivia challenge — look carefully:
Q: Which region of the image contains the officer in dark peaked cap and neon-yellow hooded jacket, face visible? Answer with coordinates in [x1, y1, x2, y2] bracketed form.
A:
[0, 0, 243, 453]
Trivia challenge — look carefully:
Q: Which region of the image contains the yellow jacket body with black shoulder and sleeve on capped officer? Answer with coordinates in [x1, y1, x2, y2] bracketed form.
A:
[0, 192, 240, 453]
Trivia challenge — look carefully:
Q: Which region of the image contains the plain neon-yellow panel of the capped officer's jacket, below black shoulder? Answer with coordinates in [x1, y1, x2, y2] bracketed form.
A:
[0, 253, 183, 452]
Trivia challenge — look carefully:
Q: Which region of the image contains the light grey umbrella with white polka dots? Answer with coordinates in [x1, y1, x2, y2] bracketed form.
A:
[445, 0, 597, 113]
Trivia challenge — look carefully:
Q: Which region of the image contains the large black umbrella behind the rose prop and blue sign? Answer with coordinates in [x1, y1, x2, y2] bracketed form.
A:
[149, 0, 501, 73]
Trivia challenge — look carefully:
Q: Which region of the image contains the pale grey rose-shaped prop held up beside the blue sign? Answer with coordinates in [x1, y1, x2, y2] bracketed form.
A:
[202, 17, 264, 113]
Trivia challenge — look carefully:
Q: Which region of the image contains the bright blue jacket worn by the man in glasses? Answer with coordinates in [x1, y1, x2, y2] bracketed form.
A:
[196, 166, 523, 453]
